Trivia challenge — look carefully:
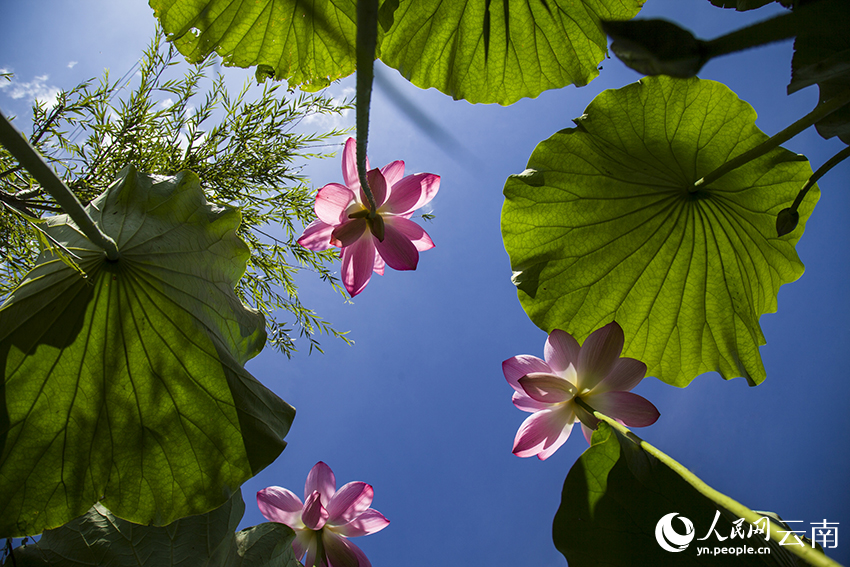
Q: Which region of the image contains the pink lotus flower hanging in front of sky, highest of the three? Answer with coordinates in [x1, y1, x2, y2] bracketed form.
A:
[298, 138, 440, 297]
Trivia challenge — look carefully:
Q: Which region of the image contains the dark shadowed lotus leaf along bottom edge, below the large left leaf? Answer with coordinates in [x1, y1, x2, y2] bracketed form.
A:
[7, 491, 300, 567]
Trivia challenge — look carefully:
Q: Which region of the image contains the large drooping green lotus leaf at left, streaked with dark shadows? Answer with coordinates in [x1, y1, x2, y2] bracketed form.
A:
[0, 167, 294, 537]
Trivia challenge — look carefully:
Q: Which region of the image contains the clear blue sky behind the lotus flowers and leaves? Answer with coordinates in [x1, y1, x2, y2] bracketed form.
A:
[0, 0, 850, 567]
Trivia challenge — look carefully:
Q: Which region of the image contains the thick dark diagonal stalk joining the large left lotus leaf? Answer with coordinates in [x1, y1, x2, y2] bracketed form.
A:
[0, 113, 120, 261]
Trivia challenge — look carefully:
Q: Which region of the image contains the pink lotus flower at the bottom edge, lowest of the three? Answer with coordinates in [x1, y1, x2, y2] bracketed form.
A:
[257, 461, 390, 567]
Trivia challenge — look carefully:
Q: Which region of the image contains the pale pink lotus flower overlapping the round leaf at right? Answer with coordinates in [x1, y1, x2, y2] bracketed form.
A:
[502, 322, 660, 460]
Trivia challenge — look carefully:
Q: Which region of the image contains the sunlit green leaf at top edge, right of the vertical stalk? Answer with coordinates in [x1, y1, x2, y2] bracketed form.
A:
[379, 0, 645, 104]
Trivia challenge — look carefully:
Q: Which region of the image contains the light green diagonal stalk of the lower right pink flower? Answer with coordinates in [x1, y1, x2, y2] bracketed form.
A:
[575, 398, 841, 567]
